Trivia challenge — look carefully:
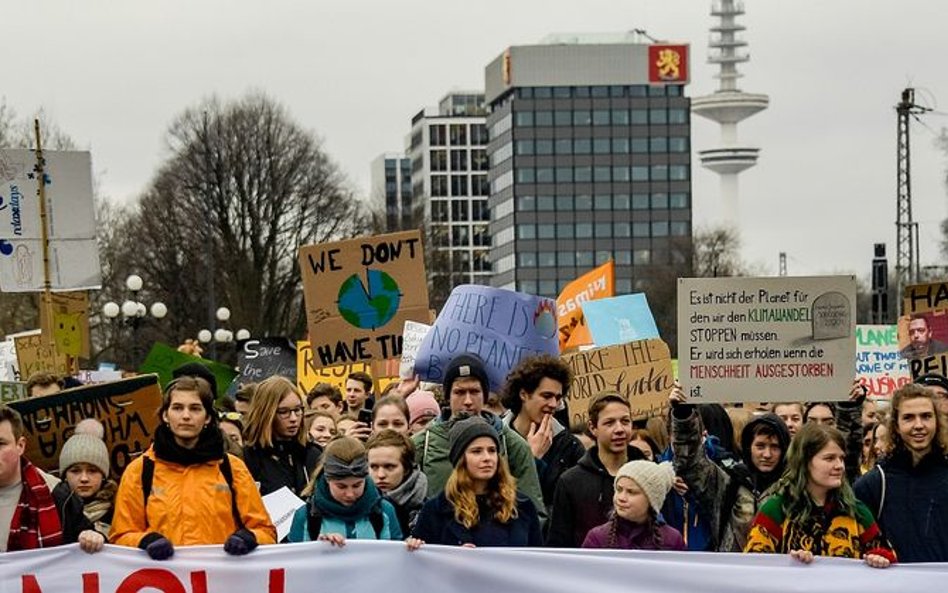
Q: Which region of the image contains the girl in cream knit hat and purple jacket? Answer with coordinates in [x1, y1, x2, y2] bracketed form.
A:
[583, 460, 686, 551]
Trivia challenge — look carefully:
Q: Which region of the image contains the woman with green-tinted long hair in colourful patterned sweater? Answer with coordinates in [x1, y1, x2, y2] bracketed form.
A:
[744, 422, 895, 568]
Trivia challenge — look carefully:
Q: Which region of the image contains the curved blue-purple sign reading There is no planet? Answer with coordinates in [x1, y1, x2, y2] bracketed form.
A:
[415, 284, 559, 395]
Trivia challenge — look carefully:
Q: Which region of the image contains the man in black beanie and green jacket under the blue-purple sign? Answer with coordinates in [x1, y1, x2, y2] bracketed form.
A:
[412, 354, 546, 520]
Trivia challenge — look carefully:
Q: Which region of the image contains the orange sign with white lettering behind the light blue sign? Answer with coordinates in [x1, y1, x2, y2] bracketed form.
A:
[556, 260, 616, 352]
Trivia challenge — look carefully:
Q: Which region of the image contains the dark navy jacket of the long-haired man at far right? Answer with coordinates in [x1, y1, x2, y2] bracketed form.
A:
[853, 446, 948, 562]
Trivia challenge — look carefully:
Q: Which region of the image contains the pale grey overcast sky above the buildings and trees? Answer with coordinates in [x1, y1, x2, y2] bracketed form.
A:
[0, 0, 948, 277]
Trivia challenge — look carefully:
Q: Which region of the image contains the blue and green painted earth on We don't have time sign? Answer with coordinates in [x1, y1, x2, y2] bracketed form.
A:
[338, 270, 402, 329]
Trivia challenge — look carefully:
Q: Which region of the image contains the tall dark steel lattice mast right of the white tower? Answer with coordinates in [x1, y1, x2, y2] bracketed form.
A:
[895, 88, 930, 310]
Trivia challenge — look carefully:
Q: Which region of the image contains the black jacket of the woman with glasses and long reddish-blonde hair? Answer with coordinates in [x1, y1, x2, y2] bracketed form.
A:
[244, 441, 322, 496]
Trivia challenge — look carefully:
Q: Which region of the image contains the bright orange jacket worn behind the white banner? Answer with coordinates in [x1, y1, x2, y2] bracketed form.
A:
[109, 448, 276, 547]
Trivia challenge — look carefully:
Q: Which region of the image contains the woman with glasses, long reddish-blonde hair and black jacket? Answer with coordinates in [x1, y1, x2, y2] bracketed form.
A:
[244, 375, 322, 496]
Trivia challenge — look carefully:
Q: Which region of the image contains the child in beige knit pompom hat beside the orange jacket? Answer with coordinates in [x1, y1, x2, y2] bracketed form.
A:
[56, 434, 118, 537]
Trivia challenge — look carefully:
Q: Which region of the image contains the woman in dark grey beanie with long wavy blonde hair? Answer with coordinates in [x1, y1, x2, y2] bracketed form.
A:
[412, 416, 543, 547]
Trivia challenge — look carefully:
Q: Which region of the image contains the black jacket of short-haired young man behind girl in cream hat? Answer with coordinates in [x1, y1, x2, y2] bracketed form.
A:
[546, 445, 644, 548]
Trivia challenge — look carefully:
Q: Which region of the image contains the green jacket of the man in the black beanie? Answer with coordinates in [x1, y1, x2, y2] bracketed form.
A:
[412, 412, 546, 521]
